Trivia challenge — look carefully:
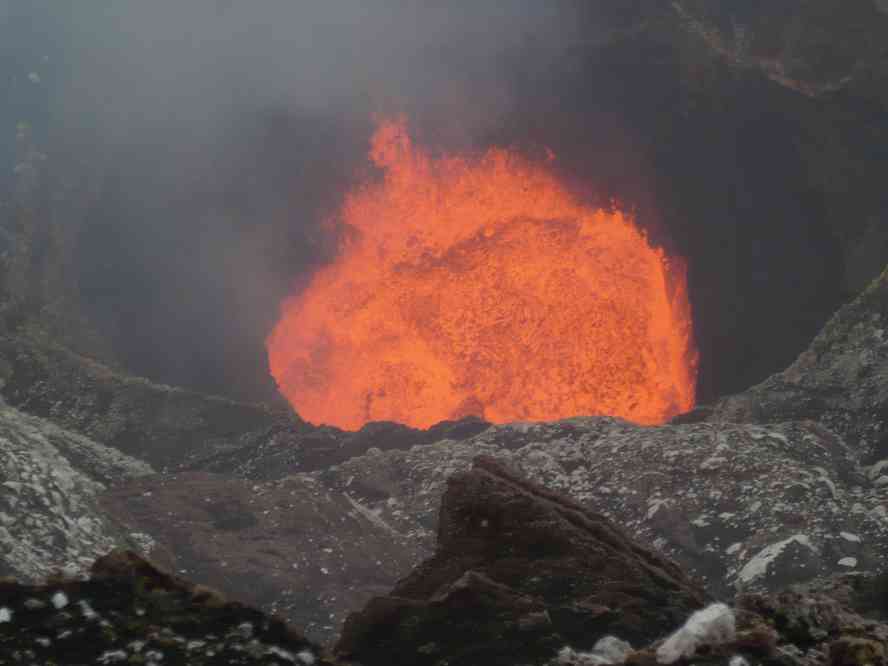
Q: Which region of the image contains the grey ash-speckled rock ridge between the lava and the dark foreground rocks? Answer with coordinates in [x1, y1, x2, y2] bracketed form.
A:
[0, 264, 888, 644]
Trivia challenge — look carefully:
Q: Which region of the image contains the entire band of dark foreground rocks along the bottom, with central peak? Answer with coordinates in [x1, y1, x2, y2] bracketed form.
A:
[0, 457, 888, 666]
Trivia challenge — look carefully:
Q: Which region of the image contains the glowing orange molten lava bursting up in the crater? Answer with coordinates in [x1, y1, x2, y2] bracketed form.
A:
[268, 122, 696, 429]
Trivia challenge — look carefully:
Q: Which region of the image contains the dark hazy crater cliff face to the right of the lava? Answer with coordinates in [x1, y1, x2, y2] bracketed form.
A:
[500, 0, 888, 401]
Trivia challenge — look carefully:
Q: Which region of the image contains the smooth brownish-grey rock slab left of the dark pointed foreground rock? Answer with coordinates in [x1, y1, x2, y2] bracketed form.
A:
[102, 472, 425, 641]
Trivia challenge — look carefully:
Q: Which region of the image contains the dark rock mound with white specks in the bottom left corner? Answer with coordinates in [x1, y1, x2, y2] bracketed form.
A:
[0, 551, 332, 666]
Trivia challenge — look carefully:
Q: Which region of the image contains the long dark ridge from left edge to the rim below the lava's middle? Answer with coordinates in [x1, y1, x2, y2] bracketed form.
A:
[0, 335, 487, 470]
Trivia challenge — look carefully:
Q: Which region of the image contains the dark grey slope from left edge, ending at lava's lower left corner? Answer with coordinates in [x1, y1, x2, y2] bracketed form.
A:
[0, 336, 294, 469]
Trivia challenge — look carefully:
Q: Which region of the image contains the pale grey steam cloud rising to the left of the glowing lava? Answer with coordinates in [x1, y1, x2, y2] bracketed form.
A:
[0, 0, 588, 398]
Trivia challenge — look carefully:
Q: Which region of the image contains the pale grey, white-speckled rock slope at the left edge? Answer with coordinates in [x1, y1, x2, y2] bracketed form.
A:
[0, 405, 154, 581]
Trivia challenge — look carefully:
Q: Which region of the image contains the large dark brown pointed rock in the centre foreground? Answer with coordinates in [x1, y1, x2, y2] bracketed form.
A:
[338, 458, 706, 666]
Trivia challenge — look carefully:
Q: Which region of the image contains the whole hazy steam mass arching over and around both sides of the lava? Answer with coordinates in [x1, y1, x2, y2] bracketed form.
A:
[0, 0, 848, 401]
